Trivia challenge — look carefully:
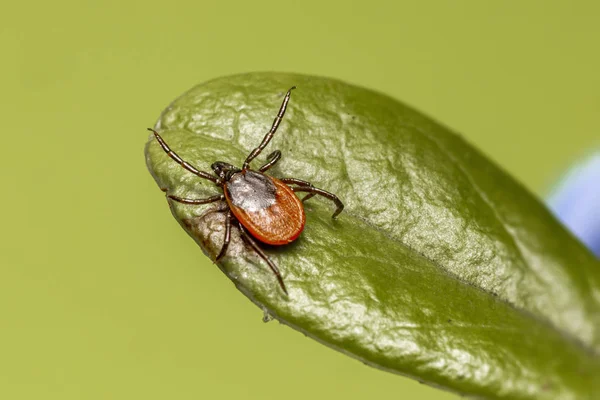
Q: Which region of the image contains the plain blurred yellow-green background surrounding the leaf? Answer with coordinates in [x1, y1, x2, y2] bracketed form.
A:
[0, 1, 600, 400]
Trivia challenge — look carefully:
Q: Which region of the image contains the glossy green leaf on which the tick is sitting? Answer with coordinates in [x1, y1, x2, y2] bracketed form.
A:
[146, 73, 600, 399]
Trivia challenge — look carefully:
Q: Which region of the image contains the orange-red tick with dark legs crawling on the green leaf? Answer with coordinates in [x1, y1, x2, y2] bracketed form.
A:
[148, 86, 344, 294]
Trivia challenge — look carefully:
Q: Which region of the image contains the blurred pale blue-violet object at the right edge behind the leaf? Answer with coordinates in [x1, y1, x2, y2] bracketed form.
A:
[548, 153, 600, 257]
